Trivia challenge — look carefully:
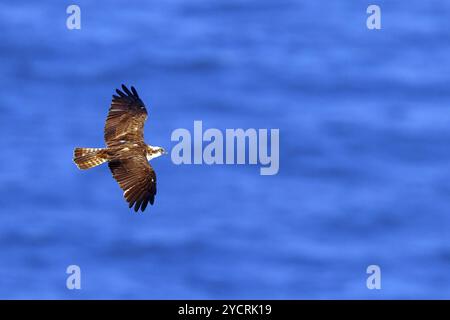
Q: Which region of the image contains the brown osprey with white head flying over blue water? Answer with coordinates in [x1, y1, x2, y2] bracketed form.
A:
[73, 85, 166, 212]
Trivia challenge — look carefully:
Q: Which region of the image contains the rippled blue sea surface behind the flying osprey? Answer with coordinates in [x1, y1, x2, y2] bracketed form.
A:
[0, 0, 450, 299]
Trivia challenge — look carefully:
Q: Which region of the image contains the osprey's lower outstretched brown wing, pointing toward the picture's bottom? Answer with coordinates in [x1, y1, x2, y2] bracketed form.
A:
[108, 155, 156, 212]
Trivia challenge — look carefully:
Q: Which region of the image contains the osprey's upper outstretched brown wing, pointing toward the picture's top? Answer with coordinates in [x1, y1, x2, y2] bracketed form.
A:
[105, 85, 147, 147]
